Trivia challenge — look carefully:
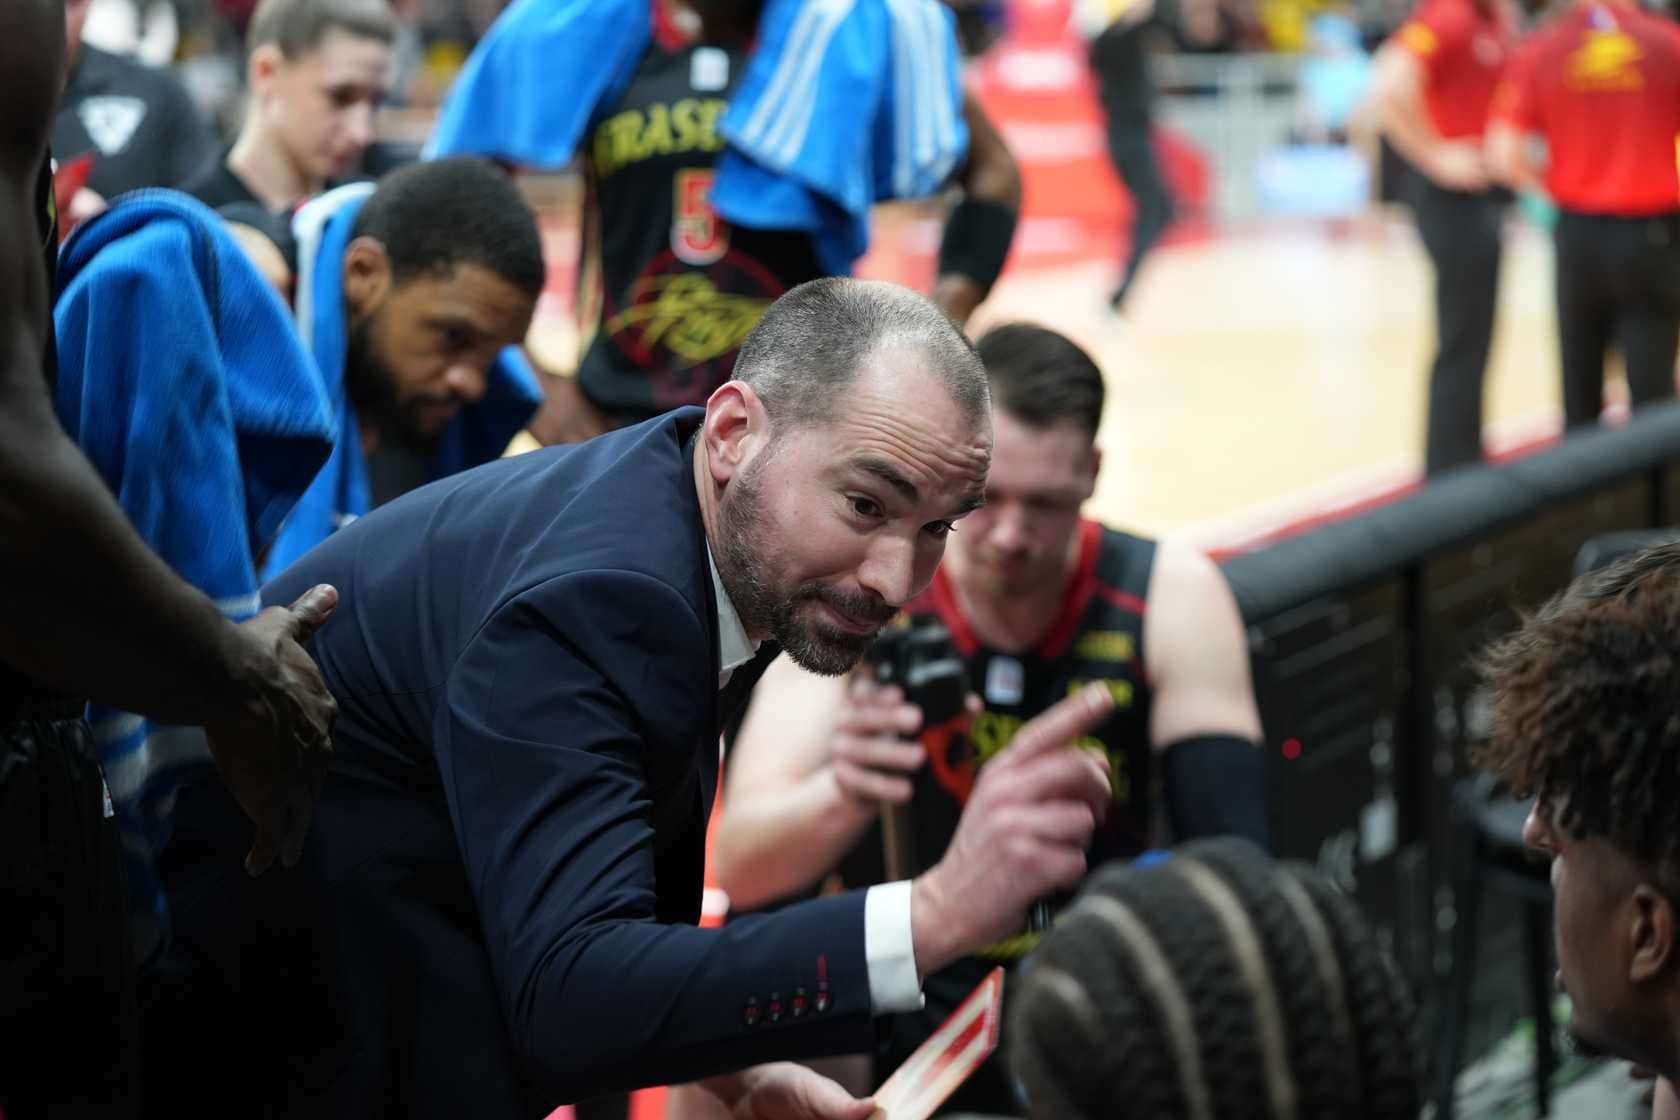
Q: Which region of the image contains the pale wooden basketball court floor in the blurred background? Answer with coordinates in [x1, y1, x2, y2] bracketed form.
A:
[979, 217, 1572, 546]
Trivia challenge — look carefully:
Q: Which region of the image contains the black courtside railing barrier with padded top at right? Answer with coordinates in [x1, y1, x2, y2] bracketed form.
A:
[1225, 403, 1680, 984]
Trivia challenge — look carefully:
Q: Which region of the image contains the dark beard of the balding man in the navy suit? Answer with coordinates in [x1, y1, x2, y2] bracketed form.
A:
[717, 448, 895, 677]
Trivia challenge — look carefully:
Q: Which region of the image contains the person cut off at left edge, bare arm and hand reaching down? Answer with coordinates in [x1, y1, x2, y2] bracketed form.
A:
[0, 0, 336, 1120]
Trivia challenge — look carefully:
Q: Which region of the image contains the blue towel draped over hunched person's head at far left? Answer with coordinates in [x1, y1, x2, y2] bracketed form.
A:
[54, 191, 334, 950]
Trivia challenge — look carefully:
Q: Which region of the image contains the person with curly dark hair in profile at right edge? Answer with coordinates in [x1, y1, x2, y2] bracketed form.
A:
[1477, 544, 1680, 1100]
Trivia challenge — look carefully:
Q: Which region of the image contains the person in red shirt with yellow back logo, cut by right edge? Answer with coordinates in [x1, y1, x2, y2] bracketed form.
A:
[1487, 0, 1680, 428]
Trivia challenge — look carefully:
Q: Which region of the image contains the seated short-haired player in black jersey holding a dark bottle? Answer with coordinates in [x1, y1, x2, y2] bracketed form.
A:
[714, 324, 1268, 1115]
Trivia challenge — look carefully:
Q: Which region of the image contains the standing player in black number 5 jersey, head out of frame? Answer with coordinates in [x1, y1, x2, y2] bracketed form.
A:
[432, 0, 1021, 442]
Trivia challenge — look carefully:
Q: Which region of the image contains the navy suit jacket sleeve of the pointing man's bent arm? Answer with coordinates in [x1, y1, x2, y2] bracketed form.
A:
[435, 571, 874, 1100]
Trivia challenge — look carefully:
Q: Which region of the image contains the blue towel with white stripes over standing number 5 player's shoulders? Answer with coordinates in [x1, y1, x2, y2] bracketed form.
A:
[427, 0, 968, 275]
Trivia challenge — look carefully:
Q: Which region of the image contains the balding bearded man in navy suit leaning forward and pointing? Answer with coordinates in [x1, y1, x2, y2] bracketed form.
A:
[148, 280, 1109, 1120]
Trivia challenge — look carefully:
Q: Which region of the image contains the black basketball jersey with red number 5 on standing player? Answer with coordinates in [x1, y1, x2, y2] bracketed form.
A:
[578, 5, 823, 418]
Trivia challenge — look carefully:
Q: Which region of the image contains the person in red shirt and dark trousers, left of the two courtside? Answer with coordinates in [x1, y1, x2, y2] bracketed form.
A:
[1376, 0, 1517, 475]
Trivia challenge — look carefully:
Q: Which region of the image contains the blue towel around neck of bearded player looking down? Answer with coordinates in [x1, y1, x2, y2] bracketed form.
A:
[262, 183, 543, 581]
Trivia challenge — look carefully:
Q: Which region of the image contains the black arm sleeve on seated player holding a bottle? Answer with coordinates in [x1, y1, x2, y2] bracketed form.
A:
[1163, 735, 1272, 851]
